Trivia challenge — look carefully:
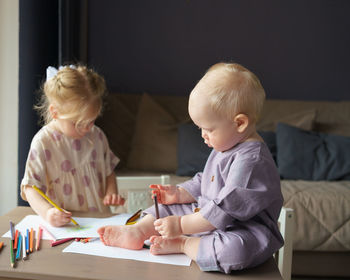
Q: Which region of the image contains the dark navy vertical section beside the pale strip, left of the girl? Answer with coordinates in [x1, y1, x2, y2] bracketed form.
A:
[18, 0, 58, 205]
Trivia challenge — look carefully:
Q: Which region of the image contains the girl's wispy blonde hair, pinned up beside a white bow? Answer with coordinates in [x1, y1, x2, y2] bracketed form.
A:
[34, 65, 106, 126]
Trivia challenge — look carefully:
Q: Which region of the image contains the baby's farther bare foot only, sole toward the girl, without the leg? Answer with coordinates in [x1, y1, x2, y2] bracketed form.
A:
[97, 225, 146, 250]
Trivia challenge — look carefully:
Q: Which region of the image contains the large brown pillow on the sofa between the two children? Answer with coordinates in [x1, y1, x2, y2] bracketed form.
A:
[127, 94, 177, 173]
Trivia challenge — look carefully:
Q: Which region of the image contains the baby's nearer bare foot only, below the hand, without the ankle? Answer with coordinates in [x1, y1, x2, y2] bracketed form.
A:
[150, 236, 186, 255]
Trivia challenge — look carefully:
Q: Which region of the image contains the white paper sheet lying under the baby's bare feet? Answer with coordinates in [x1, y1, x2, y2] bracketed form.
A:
[63, 240, 191, 266]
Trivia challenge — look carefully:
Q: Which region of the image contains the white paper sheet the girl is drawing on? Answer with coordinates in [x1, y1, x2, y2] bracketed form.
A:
[2, 214, 132, 240]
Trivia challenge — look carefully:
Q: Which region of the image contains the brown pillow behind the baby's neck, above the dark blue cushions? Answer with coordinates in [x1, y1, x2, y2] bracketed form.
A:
[256, 109, 316, 131]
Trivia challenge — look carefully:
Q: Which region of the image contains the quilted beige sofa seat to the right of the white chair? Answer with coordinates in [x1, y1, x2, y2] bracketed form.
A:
[281, 180, 350, 250]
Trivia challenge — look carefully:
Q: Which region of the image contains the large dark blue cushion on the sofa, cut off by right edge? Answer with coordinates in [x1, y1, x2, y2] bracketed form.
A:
[276, 123, 350, 181]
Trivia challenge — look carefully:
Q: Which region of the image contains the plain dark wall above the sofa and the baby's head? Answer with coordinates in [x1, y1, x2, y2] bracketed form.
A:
[88, 0, 350, 100]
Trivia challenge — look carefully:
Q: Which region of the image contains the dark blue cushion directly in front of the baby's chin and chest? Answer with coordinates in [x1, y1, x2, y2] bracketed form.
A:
[176, 122, 212, 176]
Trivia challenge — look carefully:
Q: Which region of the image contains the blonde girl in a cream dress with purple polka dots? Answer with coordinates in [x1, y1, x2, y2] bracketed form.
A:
[21, 65, 124, 226]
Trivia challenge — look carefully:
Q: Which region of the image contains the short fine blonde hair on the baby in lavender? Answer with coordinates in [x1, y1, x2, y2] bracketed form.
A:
[192, 63, 265, 123]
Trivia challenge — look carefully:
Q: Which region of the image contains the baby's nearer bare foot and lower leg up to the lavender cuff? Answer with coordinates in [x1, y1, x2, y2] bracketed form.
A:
[150, 235, 201, 261]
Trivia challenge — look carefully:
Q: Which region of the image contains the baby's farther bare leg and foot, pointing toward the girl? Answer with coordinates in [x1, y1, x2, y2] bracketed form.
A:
[97, 215, 159, 250]
